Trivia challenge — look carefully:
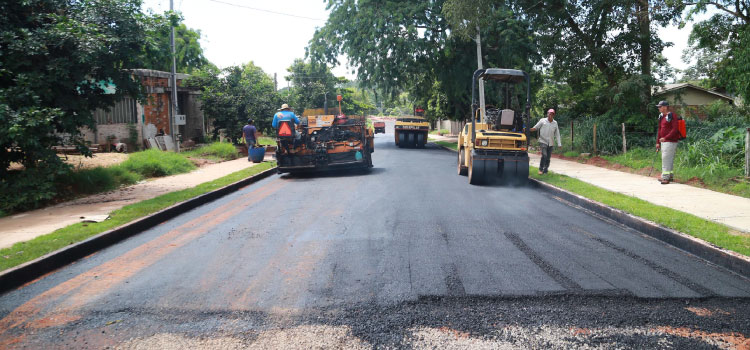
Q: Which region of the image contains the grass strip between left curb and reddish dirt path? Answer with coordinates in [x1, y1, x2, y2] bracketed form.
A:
[0, 162, 276, 271]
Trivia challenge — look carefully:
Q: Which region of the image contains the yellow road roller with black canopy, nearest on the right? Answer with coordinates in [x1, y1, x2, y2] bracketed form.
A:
[458, 68, 531, 185]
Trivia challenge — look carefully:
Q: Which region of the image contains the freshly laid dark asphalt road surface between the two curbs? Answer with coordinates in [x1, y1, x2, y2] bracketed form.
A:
[0, 124, 750, 349]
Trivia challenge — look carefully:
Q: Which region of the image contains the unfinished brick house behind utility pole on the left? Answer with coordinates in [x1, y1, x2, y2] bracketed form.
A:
[82, 69, 206, 149]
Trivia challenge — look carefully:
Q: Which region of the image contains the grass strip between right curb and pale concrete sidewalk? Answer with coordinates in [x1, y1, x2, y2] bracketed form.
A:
[529, 167, 750, 256]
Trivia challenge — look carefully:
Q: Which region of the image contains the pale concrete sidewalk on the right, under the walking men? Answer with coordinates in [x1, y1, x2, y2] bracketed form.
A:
[529, 154, 750, 233]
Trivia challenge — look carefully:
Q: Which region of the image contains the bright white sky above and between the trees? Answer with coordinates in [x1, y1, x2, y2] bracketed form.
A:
[144, 0, 706, 83]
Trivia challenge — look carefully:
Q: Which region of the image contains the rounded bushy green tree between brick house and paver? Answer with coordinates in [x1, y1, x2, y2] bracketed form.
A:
[187, 62, 281, 143]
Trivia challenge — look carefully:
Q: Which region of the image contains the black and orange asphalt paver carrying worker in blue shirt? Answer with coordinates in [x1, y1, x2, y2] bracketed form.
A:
[276, 111, 375, 173]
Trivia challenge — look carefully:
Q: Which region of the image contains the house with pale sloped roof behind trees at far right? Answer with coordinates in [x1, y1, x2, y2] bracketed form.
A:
[653, 83, 734, 119]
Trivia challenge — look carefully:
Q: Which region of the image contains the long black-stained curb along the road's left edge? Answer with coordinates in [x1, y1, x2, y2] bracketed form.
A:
[0, 167, 276, 293]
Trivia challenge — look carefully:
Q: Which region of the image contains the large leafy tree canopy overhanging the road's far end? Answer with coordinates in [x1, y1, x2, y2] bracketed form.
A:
[308, 0, 540, 119]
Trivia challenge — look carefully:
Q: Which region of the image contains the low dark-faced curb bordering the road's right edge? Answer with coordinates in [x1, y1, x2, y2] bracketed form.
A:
[433, 143, 750, 277]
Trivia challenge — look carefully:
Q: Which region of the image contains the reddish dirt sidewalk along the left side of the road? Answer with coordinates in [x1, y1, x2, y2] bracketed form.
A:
[0, 158, 269, 248]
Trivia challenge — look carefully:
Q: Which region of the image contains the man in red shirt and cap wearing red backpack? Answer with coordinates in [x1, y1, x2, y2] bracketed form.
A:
[656, 101, 680, 185]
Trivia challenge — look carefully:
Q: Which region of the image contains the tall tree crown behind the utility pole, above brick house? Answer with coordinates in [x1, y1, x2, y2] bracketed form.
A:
[141, 12, 211, 74]
